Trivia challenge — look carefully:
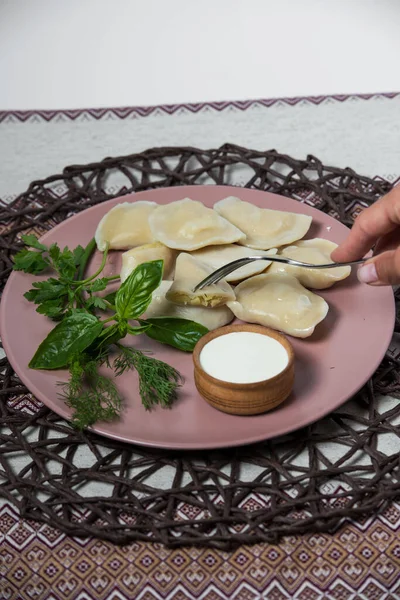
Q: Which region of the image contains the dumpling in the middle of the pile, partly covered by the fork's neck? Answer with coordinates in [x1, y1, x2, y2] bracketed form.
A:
[191, 244, 277, 281]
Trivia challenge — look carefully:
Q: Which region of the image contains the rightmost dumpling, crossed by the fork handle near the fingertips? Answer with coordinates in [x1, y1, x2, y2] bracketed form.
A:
[268, 238, 351, 290]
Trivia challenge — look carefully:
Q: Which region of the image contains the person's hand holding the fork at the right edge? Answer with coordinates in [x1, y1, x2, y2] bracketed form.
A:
[332, 185, 400, 285]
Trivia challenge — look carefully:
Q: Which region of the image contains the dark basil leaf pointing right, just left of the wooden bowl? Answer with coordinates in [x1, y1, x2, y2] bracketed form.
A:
[139, 317, 208, 352]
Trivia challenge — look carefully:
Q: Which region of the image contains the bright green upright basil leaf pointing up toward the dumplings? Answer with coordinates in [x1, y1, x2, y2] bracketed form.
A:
[115, 260, 163, 319]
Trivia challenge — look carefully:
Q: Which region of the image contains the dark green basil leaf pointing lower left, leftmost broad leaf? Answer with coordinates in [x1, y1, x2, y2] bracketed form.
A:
[29, 312, 103, 369]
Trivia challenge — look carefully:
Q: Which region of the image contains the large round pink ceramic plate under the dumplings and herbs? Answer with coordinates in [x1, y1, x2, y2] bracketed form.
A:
[0, 186, 394, 449]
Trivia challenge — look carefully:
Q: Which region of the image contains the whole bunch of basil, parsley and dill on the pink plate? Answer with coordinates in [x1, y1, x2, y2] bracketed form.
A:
[14, 235, 208, 429]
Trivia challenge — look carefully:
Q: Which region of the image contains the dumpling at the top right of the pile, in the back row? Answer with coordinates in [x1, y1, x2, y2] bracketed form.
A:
[214, 196, 312, 250]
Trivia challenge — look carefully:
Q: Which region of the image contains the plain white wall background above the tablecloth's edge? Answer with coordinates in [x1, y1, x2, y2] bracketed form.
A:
[0, 0, 400, 110]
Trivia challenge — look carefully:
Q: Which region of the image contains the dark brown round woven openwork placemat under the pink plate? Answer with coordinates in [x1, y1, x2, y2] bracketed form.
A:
[0, 144, 400, 548]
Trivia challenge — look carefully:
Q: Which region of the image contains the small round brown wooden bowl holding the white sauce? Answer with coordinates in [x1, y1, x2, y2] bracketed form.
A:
[193, 324, 294, 415]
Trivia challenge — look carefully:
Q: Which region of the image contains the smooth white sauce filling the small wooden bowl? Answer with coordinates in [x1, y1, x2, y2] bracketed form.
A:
[200, 331, 289, 383]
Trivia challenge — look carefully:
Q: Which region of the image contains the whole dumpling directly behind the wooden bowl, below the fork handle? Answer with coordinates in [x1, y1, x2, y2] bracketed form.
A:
[228, 273, 329, 338]
